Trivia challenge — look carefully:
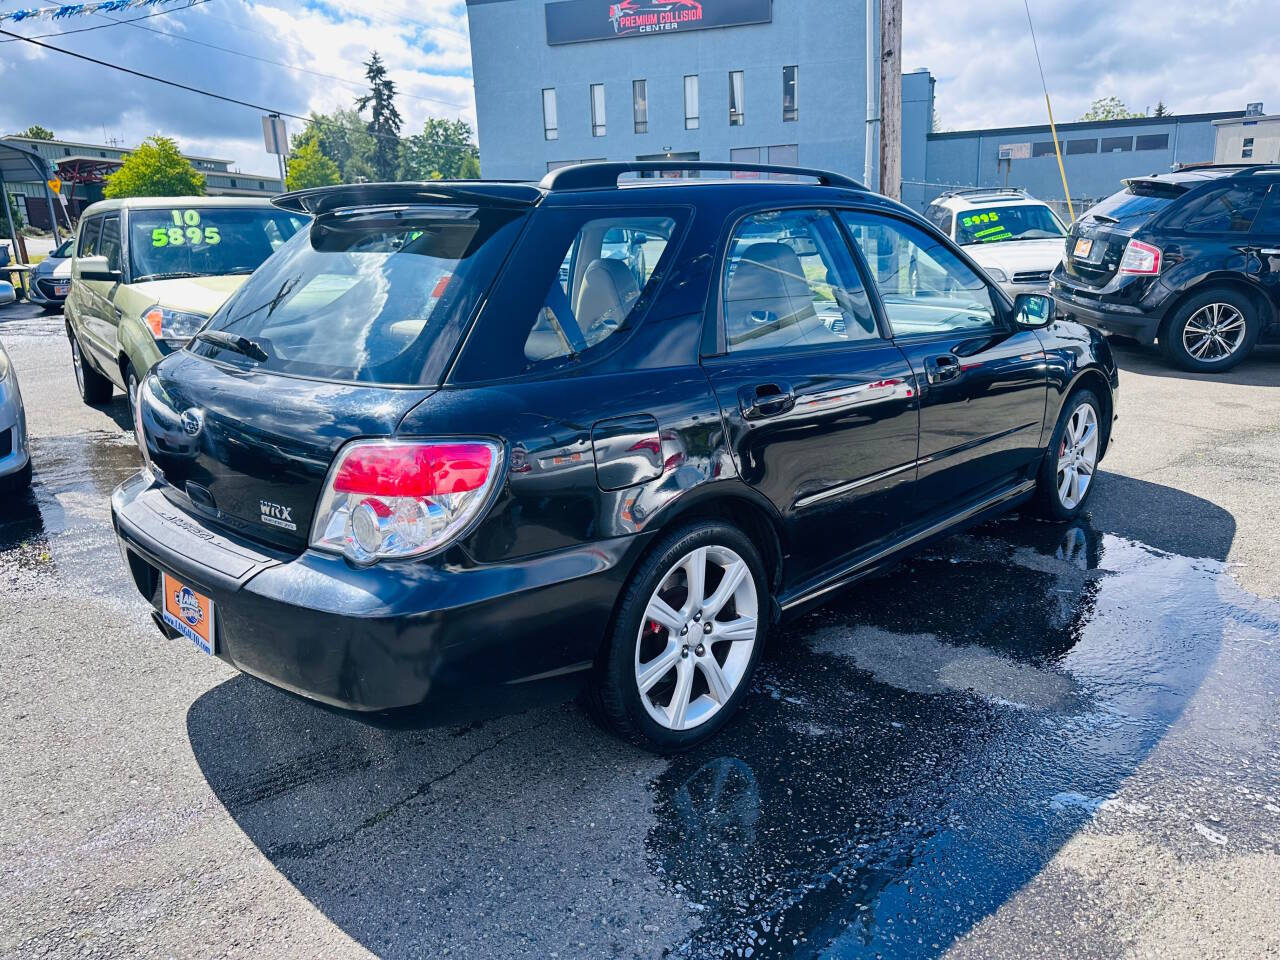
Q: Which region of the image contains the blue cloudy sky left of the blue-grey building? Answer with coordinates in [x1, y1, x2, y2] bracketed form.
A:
[0, 0, 475, 173]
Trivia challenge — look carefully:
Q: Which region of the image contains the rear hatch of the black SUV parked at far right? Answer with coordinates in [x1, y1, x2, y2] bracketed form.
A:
[1062, 178, 1188, 287]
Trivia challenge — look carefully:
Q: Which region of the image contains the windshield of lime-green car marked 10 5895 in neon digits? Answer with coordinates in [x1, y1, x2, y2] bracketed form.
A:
[129, 206, 306, 283]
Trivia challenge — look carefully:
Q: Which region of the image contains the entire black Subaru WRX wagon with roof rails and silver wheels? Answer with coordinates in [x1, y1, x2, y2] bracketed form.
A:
[111, 161, 1117, 750]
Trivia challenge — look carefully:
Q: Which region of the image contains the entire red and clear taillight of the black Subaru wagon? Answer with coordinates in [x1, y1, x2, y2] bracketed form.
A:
[311, 440, 502, 563]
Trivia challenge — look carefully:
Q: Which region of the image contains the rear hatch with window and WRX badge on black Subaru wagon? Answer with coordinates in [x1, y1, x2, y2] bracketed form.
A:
[140, 205, 527, 552]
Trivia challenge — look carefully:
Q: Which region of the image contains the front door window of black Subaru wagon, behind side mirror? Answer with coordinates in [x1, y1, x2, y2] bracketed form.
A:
[841, 211, 1001, 337]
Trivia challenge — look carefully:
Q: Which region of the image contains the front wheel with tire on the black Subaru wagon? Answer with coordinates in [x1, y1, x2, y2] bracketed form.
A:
[1036, 390, 1105, 520]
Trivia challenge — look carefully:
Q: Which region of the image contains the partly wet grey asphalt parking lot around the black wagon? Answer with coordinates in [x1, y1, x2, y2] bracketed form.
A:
[0, 306, 1280, 957]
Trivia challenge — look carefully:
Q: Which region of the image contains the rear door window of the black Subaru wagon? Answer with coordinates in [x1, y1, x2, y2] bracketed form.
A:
[722, 210, 879, 353]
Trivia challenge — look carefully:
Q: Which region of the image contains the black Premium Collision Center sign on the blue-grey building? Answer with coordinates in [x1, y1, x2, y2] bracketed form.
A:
[547, 0, 773, 44]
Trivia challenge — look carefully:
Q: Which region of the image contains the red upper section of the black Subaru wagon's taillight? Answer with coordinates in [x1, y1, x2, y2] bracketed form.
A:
[333, 443, 493, 497]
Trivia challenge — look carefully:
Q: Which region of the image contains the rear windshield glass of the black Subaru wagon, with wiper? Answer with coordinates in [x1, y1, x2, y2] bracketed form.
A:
[191, 206, 522, 385]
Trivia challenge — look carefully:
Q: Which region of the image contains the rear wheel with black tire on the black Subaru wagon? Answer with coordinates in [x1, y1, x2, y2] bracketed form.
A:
[593, 521, 771, 753]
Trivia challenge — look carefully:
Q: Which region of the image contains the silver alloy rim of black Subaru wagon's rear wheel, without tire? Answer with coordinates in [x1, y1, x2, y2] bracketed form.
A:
[635, 545, 759, 730]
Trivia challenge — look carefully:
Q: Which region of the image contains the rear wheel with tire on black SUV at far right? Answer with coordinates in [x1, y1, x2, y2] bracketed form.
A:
[1160, 287, 1261, 374]
